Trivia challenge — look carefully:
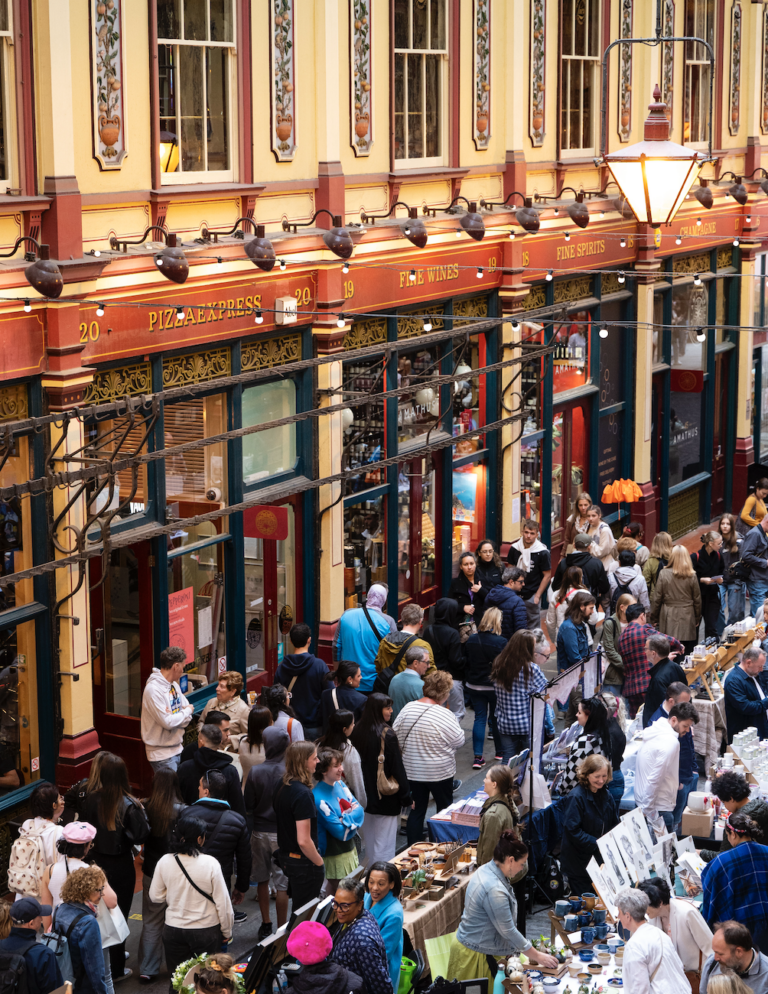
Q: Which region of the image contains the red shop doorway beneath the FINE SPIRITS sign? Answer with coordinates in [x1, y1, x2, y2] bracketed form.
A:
[551, 401, 599, 569]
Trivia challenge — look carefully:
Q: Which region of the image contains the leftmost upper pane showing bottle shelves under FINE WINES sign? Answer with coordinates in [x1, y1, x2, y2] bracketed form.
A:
[342, 359, 386, 493]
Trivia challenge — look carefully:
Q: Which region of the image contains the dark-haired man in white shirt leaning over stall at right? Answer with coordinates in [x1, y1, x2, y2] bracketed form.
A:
[635, 703, 699, 838]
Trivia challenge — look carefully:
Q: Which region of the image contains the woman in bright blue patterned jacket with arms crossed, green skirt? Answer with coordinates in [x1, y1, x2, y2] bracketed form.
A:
[312, 749, 365, 890]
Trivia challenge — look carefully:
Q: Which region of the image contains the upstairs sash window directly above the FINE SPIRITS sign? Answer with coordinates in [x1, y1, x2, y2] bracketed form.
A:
[560, 0, 602, 152]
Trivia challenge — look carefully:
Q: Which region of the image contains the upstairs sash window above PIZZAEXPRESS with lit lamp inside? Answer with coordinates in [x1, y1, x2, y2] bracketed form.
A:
[156, 0, 235, 183]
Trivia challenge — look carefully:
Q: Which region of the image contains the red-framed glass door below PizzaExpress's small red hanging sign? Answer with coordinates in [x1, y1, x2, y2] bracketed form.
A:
[244, 497, 303, 690]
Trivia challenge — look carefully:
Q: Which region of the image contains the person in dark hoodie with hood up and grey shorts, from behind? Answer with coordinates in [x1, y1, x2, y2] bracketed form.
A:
[244, 726, 291, 942]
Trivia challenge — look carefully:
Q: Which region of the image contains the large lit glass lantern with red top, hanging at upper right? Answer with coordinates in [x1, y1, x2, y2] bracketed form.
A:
[603, 86, 704, 228]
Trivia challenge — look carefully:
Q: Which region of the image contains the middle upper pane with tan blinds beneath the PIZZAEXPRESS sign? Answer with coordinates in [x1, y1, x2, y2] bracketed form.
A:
[165, 394, 227, 507]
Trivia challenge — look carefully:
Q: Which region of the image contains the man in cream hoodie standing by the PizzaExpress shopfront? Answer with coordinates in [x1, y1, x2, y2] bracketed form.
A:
[141, 645, 195, 770]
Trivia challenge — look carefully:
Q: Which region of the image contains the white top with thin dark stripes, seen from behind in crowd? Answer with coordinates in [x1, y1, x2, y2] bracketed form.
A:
[393, 701, 464, 783]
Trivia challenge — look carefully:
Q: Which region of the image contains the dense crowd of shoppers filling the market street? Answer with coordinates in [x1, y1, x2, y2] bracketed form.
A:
[10, 494, 768, 994]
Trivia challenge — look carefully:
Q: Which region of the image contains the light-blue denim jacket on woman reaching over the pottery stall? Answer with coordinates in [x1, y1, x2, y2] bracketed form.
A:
[456, 860, 531, 956]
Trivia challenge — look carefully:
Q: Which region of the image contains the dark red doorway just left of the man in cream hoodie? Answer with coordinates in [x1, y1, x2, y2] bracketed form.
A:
[90, 542, 155, 789]
